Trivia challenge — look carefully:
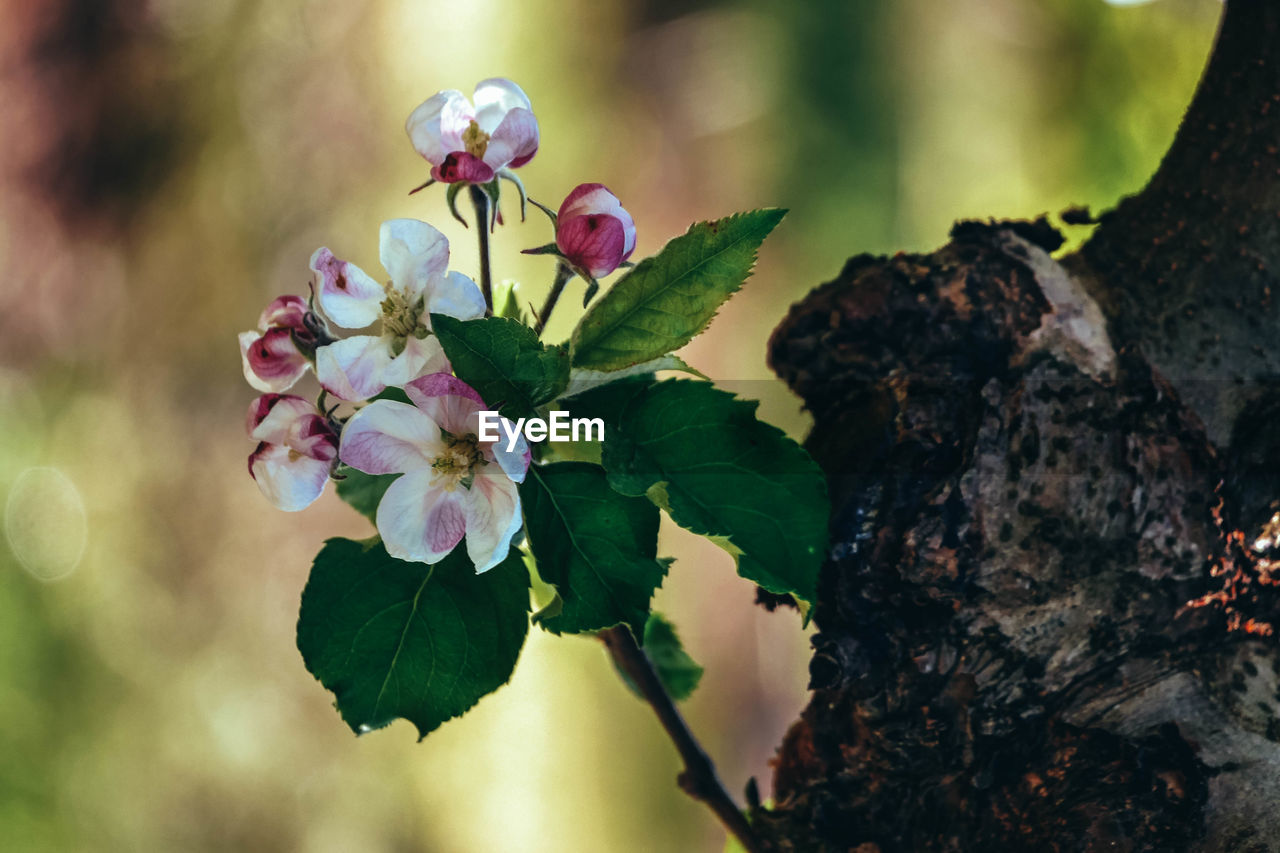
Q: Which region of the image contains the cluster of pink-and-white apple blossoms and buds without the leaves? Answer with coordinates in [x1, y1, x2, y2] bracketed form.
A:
[239, 78, 636, 571]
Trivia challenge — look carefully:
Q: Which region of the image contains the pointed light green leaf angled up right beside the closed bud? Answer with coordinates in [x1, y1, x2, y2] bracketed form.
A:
[570, 207, 786, 370]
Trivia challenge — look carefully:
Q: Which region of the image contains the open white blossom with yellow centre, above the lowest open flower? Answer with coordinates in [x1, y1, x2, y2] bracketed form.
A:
[311, 219, 485, 401]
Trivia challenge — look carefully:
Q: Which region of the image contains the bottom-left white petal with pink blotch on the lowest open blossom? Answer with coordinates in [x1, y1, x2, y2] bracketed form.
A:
[376, 470, 466, 562]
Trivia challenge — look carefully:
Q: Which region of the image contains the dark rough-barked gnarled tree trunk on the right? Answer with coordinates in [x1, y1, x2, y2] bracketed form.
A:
[754, 0, 1280, 853]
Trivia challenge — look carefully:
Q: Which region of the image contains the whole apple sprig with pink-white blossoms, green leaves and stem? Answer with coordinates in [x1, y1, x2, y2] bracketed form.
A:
[239, 78, 828, 849]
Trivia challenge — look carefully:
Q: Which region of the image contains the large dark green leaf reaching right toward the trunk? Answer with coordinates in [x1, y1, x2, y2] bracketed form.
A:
[602, 379, 829, 602]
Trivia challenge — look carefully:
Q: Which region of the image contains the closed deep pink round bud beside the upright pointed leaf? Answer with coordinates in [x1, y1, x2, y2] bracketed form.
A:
[556, 183, 636, 278]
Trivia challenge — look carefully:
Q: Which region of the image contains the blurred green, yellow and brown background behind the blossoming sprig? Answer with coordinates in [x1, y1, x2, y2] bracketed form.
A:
[0, 0, 1220, 853]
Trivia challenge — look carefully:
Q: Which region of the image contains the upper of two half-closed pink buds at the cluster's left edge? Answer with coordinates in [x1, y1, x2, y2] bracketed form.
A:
[239, 290, 329, 393]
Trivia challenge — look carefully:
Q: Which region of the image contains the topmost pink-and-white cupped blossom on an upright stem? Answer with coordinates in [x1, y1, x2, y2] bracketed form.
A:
[404, 77, 538, 183]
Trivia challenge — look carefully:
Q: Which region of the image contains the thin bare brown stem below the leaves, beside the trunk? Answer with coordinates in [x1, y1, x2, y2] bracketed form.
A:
[600, 626, 764, 853]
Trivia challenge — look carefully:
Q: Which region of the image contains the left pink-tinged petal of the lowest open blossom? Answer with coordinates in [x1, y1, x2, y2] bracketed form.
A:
[338, 400, 444, 474]
